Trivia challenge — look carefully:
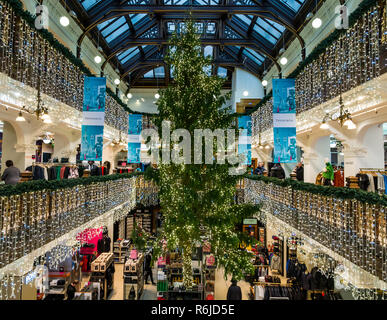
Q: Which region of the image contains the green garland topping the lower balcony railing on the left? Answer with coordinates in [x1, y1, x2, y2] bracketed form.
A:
[0, 172, 143, 197]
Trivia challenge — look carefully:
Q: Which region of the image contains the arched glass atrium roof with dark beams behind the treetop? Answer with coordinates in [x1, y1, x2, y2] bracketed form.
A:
[73, 0, 315, 85]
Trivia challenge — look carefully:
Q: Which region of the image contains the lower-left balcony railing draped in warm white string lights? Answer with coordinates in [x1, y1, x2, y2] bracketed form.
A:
[0, 176, 158, 268]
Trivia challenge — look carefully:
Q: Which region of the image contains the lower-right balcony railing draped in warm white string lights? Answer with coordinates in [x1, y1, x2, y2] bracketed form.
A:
[244, 178, 387, 281]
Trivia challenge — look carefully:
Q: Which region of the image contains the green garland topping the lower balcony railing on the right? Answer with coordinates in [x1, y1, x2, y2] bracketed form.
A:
[245, 175, 387, 206]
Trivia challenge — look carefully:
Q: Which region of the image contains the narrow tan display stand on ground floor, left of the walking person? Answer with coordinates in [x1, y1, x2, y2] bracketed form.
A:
[123, 253, 144, 300]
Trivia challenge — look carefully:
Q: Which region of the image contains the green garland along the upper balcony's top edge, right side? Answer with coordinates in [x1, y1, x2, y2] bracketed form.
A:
[239, 0, 379, 116]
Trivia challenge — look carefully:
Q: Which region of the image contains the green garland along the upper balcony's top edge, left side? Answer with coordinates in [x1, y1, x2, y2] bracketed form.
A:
[0, 0, 156, 115]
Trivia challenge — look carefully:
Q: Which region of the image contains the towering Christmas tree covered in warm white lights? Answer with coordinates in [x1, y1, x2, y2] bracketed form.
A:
[148, 20, 257, 288]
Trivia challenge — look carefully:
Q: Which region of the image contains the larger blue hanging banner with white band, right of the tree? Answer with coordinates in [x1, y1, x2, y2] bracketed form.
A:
[273, 79, 297, 163]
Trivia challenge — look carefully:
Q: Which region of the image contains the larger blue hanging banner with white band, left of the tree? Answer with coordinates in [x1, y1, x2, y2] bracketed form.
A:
[81, 77, 106, 161]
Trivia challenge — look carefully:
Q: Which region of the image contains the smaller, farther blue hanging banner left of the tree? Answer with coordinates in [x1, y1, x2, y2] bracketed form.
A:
[128, 114, 142, 163]
